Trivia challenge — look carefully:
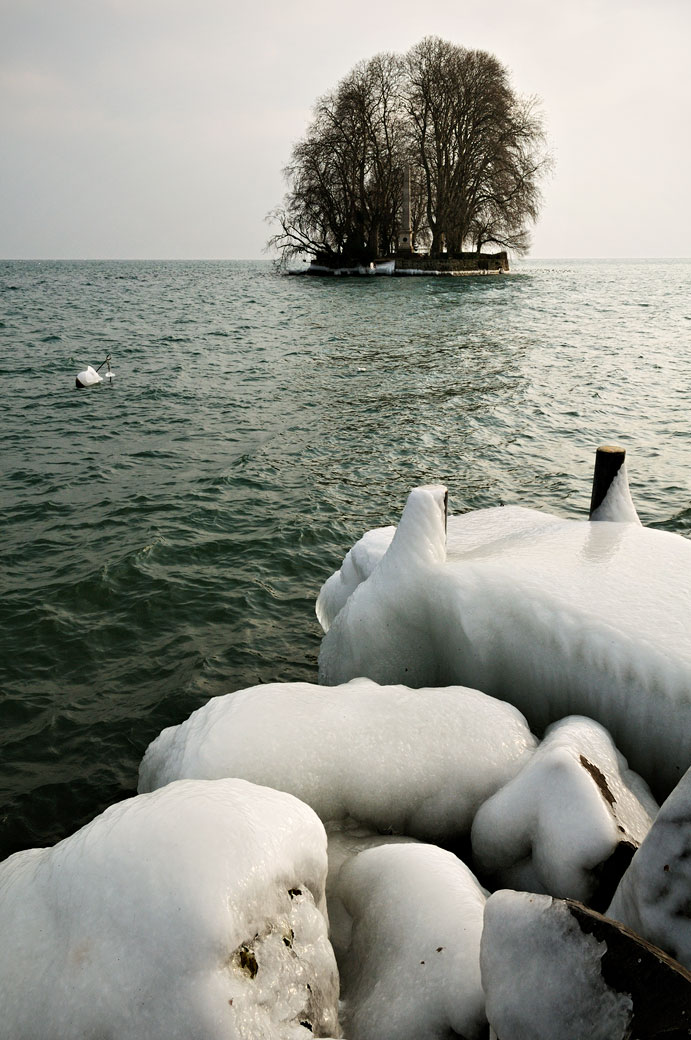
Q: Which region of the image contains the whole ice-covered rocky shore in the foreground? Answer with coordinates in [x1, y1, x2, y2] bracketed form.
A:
[0, 457, 691, 1040]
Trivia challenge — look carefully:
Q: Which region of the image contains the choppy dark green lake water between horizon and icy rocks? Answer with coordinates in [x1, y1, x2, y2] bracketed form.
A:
[0, 261, 691, 856]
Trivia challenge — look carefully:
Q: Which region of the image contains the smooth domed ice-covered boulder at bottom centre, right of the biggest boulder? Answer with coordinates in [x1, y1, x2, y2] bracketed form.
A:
[339, 843, 487, 1040]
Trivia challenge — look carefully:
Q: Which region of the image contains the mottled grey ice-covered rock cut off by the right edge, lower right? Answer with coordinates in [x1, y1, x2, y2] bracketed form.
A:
[607, 770, 691, 971]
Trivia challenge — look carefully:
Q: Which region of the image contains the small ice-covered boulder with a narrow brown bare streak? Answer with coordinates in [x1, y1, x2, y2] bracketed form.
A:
[471, 717, 658, 910]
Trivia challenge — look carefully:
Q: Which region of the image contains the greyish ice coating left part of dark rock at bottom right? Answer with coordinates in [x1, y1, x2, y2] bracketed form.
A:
[480, 891, 632, 1040]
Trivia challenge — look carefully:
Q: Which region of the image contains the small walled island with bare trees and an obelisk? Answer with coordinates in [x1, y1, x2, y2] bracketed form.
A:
[267, 36, 551, 276]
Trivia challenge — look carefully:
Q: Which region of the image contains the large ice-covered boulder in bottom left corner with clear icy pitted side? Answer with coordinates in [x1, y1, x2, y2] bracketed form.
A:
[0, 780, 338, 1040]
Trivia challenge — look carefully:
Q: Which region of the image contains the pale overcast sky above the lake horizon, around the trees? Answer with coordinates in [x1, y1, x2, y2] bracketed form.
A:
[0, 0, 691, 259]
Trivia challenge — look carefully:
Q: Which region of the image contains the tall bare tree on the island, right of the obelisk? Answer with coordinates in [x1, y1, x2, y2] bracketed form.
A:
[405, 36, 549, 255]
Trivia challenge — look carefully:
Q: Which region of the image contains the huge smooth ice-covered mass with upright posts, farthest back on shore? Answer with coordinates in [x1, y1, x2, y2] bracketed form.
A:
[319, 487, 691, 795]
